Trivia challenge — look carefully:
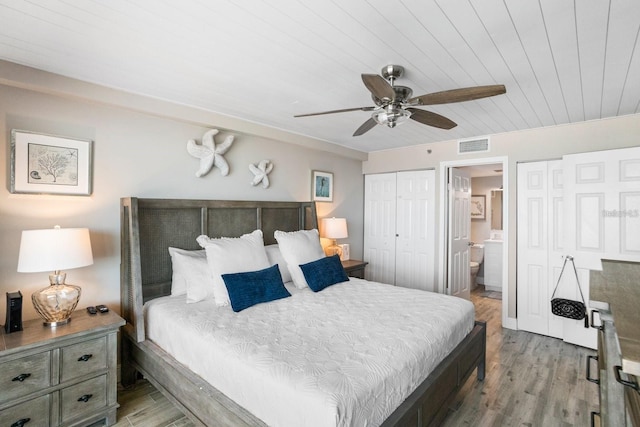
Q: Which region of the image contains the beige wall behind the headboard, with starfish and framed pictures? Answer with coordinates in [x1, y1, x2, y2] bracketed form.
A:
[0, 67, 363, 323]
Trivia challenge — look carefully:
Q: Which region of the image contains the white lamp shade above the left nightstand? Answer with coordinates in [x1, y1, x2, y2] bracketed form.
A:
[18, 227, 93, 273]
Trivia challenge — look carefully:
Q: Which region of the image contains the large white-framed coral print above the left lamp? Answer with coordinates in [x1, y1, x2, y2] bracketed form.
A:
[10, 129, 93, 196]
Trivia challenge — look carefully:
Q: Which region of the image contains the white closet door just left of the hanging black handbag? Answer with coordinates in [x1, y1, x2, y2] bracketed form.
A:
[517, 160, 563, 338]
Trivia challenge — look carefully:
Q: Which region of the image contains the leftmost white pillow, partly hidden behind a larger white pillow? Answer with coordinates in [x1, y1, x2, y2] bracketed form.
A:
[169, 247, 211, 296]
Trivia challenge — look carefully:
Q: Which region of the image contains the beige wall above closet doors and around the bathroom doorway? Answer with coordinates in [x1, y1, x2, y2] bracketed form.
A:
[363, 114, 640, 318]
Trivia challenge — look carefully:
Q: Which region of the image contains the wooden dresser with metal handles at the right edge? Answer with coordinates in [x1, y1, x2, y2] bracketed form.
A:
[587, 260, 640, 427]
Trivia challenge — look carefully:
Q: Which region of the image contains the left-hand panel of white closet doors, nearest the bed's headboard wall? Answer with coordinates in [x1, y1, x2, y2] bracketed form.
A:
[364, 173, 396, 284]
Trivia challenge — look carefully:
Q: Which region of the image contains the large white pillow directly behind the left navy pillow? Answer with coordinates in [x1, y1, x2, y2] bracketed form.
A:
[196, 230, 271, 306]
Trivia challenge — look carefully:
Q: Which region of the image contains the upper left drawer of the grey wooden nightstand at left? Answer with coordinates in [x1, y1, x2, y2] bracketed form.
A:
[0, 351, 51, 402]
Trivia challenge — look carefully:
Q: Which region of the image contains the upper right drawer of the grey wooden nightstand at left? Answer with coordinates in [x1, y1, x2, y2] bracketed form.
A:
[60, 337, 107, 382]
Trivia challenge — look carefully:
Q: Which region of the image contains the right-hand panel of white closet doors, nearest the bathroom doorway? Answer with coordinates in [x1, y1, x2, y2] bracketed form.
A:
[395, 170, 436, 292]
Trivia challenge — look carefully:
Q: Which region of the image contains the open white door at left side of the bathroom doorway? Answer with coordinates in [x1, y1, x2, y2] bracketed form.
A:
[447, 168, 471, 299]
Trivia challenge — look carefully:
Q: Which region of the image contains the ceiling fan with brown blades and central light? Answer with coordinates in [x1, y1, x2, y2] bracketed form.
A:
[294, 65, 507, 136]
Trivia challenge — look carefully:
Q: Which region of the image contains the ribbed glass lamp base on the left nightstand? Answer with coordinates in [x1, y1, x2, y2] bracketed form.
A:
[31, 284, 81, 327]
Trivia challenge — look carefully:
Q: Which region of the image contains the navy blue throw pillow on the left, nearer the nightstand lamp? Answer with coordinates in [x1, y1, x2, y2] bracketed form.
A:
[222, 264, 291, 313]
